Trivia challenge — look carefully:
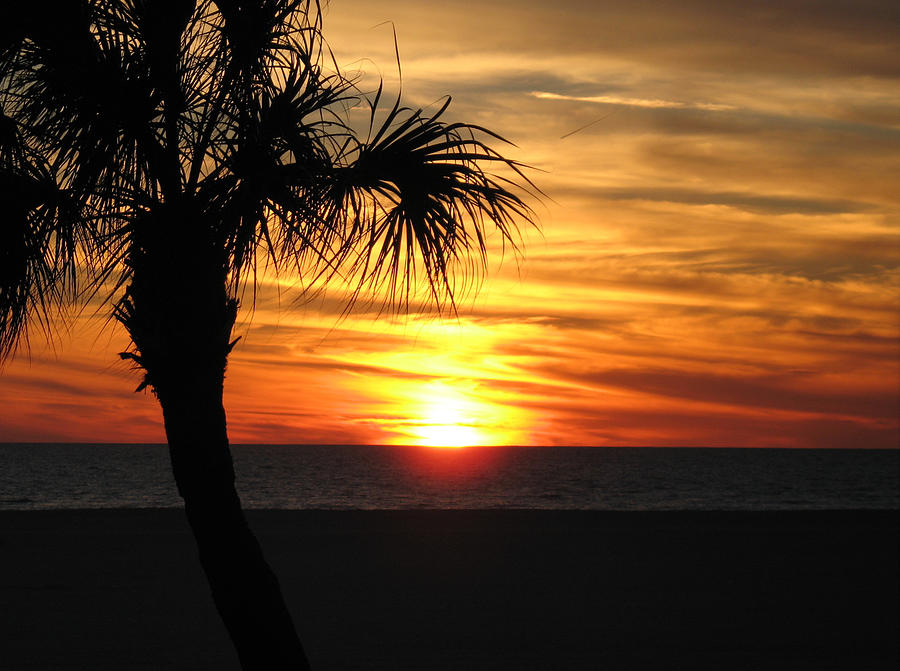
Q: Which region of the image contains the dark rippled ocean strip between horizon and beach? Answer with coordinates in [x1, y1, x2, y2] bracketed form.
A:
[0, 444, 900, 510]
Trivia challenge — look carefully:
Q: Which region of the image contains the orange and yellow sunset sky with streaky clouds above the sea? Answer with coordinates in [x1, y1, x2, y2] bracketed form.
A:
[0, 0, 900, 448]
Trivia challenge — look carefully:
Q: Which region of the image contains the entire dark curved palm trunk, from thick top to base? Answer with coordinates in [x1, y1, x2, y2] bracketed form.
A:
[116, 234, 309, 671]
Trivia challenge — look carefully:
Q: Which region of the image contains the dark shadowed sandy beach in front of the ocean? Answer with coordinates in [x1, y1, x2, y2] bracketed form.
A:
[0, 510, 900, 671]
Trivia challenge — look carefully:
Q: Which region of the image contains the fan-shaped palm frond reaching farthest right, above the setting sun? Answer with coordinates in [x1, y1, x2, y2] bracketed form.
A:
[336, 96, 540, 308]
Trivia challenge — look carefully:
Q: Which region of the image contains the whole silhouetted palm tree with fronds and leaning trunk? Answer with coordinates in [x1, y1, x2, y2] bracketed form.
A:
[0, 0, 533, 670]
